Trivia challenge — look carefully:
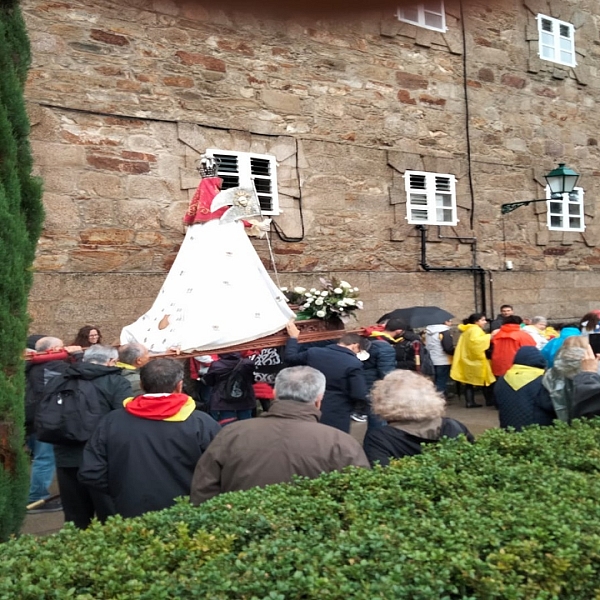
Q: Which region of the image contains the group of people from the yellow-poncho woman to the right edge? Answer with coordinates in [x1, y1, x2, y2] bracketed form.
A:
[450, 305, 600, 430]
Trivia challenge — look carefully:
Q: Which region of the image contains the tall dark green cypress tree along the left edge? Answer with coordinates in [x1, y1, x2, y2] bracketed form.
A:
[0, 0, 43, 540]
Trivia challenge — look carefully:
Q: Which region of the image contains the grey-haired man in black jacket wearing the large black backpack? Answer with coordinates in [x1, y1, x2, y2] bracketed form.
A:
[46, 344, 131, 529]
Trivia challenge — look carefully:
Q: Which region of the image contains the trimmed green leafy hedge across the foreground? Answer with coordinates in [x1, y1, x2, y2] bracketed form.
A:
[0, 420, 600, 600]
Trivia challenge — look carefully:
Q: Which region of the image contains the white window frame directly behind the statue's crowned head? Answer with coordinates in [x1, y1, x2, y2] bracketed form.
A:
[206, 148, 281, 216]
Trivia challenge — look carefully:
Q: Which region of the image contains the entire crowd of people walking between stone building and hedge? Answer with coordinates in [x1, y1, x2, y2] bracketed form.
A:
[25, 305, 600, 529]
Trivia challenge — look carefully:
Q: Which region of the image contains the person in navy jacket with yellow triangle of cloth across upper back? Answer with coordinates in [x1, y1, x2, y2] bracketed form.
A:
[494, 346, 556, 431]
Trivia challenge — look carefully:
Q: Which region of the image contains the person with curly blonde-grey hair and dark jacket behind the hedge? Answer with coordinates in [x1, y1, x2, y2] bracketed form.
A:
[363, 369, 474, 466]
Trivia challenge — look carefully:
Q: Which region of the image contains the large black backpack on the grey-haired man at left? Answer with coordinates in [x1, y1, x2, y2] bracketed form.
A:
[34, 376, 107, 445]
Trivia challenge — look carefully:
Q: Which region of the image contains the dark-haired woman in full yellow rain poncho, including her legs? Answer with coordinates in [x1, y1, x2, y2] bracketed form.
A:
[450, 313, 496, 408]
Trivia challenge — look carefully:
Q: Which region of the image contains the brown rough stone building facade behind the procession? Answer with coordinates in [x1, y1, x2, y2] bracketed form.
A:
[22, 0, 600, 341]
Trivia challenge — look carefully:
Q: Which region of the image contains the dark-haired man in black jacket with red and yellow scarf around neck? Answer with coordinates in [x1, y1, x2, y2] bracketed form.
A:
[79, 358, 221, 517]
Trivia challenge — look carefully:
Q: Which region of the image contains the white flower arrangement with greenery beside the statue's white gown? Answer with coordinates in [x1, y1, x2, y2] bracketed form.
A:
[280, 278, 363, 323]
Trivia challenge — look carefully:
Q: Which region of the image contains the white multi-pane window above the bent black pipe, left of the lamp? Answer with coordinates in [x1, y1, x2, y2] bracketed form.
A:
[404, 171, 458, 225]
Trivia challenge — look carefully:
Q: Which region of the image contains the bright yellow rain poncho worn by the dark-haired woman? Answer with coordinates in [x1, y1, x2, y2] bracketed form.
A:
[450, 323, 496, 386]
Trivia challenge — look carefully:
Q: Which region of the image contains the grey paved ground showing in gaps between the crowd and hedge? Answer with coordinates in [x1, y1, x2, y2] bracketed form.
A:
[22, 398, 498, 535]
